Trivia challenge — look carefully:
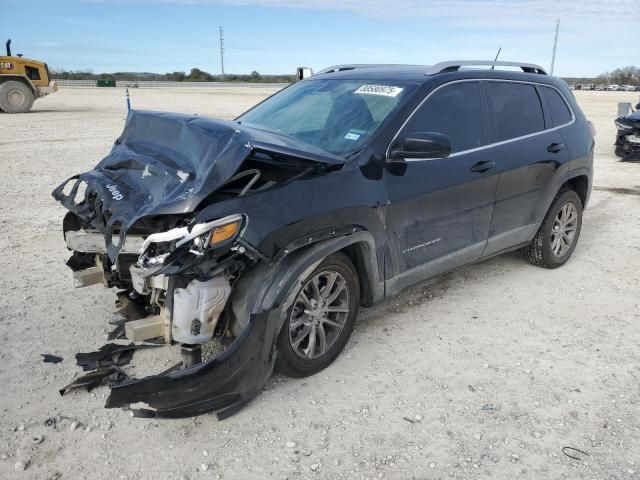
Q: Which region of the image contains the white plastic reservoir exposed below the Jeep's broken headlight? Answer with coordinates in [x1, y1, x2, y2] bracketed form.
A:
[171, 275, 231, 344]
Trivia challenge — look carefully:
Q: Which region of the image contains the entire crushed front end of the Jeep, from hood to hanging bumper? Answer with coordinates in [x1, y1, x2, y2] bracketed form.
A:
[53, 111, 338, 418]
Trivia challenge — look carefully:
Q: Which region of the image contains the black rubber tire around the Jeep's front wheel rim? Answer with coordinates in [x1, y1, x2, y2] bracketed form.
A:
[276, 253, 360, 378]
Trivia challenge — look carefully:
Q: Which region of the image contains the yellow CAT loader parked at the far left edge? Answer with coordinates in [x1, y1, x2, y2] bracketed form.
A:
[0, 39, 58, 113]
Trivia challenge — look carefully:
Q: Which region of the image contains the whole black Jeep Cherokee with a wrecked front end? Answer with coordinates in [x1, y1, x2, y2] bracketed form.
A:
[53, 61, 594, 418]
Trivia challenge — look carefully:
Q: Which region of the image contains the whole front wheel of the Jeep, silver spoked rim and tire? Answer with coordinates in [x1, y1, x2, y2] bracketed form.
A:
[276, 253, 360, 377]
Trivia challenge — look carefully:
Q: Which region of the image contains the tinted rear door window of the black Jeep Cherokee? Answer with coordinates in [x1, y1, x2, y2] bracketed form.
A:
[487, 82, 544, 142]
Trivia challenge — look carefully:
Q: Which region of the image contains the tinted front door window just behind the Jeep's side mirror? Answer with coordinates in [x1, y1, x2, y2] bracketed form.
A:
[404, 82, 484, 153]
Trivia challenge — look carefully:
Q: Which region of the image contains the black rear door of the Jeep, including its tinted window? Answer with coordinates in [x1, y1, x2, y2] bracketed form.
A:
[484, 80, 569, 256]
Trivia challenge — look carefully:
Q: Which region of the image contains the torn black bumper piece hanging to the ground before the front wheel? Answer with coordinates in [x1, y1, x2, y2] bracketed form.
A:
[105, 308, 280, 420]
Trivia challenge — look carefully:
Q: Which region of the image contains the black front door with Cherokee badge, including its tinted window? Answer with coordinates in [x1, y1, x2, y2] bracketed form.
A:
[385, 80, 498, 294]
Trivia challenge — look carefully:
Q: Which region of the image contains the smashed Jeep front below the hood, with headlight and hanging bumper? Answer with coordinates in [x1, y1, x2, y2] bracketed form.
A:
[64, 209, 279, 418]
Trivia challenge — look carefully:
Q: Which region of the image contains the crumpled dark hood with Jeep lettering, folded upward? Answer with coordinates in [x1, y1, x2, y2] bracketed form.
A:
[52, 110, 344, 260]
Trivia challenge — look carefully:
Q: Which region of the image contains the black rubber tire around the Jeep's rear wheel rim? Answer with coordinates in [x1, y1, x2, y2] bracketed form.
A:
[525, 190, 582, 268]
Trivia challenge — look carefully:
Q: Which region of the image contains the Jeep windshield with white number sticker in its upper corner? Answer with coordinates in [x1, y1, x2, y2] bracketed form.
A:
[236, 79, 415, 156]
